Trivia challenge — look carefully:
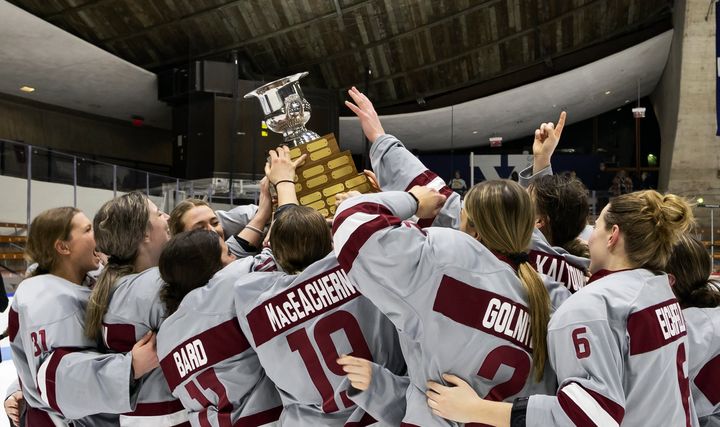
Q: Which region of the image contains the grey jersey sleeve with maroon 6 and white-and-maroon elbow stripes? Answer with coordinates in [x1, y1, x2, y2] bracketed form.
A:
[527, 313, 625, 427]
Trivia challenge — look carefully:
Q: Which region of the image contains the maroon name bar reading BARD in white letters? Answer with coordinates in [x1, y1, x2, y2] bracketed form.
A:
[160, 318, 250, 390]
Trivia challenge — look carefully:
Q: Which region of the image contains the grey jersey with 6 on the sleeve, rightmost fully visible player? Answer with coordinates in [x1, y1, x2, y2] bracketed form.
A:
[527, 269, 698, 427]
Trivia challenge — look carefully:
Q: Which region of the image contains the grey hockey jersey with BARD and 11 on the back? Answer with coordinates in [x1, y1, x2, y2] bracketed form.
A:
[157, 251, 282, 427]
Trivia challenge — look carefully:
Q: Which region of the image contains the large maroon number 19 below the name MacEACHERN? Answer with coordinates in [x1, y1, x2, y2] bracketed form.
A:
[287, 310, 372, 413]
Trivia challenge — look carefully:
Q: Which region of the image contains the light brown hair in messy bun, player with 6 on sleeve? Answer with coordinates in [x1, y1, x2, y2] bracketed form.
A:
[605, 190, 694, 271]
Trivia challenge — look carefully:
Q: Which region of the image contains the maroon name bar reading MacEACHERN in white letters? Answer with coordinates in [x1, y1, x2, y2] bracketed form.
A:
[247, 266, 360, 347]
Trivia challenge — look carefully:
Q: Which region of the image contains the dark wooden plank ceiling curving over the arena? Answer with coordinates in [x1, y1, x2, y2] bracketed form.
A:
[5, 0, 673, 114]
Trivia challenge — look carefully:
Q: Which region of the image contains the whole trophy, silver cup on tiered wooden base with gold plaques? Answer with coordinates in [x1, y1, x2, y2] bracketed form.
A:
[245, 72, 371, 218]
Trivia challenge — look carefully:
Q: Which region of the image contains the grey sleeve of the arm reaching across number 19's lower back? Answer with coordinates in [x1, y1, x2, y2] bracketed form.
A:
[345, 362, 410, 426]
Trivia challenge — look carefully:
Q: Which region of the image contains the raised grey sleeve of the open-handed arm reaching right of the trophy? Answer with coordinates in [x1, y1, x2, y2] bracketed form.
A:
[370, 135, 461, 229]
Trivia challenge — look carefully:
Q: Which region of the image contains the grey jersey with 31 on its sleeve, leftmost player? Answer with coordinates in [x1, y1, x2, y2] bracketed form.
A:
[8, 274, 137, 427]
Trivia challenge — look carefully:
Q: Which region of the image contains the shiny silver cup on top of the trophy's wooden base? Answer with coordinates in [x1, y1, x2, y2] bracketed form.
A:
[245, 71, 320, 147]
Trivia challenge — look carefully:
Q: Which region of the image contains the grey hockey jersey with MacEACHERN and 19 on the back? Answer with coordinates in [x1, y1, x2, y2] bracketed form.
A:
[235, 253, 405, 427]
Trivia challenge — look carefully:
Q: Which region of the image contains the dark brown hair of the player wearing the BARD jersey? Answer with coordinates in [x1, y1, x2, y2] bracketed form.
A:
[158, 230, 222, 316]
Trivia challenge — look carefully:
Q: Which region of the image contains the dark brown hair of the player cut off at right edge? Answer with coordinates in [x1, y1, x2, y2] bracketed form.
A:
[665, 234, 720, 308]
